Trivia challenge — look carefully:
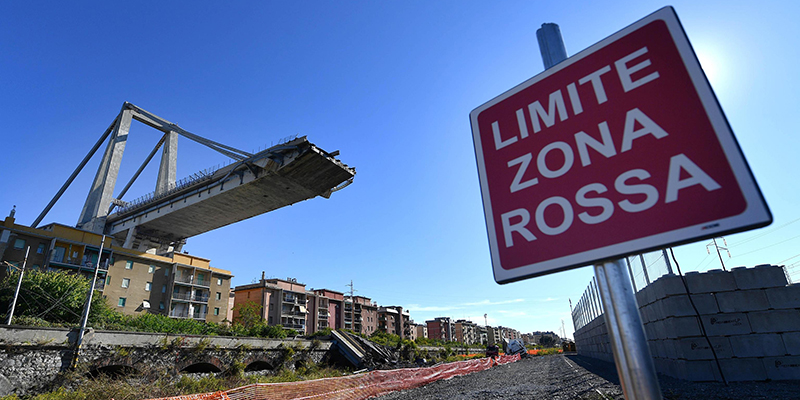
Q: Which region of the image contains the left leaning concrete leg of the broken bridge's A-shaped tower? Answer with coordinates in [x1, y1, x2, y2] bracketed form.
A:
[77, 108, 132, 233]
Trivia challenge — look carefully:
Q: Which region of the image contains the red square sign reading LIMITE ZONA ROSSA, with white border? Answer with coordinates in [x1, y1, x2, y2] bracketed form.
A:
[470, 7, 772, 283]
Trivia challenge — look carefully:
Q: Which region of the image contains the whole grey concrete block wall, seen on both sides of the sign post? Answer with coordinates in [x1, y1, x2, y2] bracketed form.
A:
[575, 265, 800, 381]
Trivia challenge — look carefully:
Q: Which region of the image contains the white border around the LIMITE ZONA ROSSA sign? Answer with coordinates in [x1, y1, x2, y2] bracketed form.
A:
[470, 6, 772, 284]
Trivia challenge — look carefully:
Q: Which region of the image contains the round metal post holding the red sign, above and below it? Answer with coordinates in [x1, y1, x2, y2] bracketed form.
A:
[536, 24, 661, 399]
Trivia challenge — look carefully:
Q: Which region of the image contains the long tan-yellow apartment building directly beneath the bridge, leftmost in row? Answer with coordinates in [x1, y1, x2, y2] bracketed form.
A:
[0, 213, 232, 322]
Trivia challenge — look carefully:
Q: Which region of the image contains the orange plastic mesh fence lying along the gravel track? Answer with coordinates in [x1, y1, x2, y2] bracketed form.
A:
[152, 354, 520, 400]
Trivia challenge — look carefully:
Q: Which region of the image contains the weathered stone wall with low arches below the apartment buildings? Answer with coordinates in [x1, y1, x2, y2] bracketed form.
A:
[0, 325, 331, 396]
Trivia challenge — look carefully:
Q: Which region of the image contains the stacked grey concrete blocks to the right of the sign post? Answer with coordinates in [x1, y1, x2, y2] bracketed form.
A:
[654, 265, 800, 381]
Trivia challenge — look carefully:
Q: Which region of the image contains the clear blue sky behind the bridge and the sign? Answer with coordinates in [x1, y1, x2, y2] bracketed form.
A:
[0, 1, 800, 336]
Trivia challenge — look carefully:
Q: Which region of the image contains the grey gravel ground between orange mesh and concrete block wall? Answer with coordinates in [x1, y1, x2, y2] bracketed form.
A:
[378, 355, 800, 400]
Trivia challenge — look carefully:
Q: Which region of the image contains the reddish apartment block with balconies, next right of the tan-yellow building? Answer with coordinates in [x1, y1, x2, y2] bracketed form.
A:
[233, 272, 308, 334]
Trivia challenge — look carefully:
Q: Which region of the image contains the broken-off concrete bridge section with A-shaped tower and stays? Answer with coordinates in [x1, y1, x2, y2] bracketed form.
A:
[32, 102, 356, 253]
